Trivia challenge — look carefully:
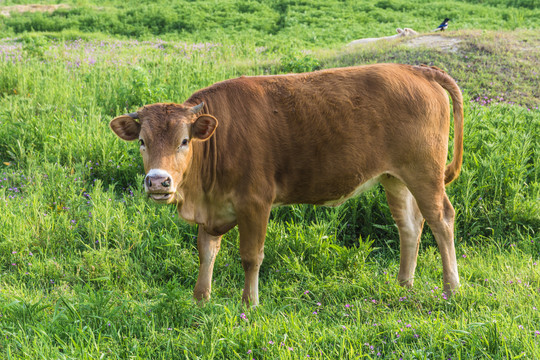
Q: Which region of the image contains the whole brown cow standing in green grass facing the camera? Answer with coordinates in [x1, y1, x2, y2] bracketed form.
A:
[110, 64, 463, 305]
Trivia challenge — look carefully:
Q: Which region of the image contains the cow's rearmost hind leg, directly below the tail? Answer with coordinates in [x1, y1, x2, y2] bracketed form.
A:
[409, 178, 459, 295]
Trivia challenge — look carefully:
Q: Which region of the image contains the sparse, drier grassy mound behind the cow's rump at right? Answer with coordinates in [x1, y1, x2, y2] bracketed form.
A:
[321, 30, 540, 108]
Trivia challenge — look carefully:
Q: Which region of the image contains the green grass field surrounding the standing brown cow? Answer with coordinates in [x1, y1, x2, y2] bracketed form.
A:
[0, 0, 540, 359]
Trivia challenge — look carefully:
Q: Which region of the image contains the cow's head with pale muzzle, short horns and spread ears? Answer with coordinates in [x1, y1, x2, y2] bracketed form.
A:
[110, 103, 217, 203]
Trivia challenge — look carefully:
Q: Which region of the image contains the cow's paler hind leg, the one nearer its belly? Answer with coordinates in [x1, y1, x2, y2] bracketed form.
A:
[381, 176, 424, 287]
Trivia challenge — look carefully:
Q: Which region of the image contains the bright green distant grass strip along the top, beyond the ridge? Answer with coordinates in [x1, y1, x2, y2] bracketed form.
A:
[0, 0, 540, 45]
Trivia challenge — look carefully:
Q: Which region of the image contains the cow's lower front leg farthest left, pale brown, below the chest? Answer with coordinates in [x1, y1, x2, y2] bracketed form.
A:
[193, 225, 221, 301]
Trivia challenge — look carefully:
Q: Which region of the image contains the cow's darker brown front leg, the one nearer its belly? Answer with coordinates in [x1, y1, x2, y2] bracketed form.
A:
[238, 202, 271, 306]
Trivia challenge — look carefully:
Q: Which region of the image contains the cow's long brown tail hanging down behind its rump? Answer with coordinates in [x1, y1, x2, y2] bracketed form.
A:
[418, 66, 463, 185]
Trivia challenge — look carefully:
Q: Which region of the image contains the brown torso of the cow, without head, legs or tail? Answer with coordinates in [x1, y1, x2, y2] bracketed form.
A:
[187, 64, 449, 204]
